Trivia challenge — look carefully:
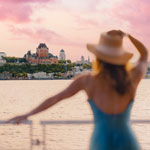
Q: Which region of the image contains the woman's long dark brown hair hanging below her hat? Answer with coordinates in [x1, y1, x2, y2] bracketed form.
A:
[93, 58, 131, 95]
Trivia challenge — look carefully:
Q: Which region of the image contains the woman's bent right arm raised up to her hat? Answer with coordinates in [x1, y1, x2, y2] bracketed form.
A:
[128, 35, 148, 84]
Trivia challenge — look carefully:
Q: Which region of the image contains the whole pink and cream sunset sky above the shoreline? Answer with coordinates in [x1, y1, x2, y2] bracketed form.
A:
[0, 0, 150, 61]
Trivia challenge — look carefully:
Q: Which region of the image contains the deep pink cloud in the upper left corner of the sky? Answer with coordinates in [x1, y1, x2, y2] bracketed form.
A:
[0, 0, 55, 23]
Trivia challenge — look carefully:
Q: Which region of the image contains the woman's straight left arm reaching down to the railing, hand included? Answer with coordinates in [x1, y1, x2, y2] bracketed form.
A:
[9, 75, 86, 124]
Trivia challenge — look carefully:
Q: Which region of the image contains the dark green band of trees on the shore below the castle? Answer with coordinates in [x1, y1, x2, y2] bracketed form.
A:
[0, 57, 91, 77]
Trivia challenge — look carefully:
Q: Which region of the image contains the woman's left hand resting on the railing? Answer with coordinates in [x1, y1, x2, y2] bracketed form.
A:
[6, 115, 28, 124]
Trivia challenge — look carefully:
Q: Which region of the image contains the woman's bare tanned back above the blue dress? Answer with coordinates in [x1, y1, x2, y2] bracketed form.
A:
[85, 71, 140, 114]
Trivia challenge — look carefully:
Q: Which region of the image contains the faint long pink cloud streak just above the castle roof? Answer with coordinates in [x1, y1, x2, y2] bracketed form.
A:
[9, 25, 84, 47]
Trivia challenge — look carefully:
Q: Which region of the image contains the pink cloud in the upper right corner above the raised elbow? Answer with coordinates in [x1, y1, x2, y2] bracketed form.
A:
[112, 0, 150, 43]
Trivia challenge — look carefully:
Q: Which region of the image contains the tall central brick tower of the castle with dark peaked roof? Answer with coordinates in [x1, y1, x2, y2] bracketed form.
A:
[36, 43, 48, 57]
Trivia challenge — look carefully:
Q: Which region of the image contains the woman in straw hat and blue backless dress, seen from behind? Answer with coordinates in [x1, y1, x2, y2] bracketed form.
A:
[10, 30, 148, 150]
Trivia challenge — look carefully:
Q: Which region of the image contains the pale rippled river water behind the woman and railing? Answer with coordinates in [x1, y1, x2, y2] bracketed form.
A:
[0, 79, 150, 150]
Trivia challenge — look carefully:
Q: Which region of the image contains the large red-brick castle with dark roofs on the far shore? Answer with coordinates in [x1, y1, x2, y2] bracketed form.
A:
[24, 43, 58, 64]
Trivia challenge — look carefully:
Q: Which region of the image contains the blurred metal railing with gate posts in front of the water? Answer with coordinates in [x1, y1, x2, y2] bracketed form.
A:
[0, 120, 150, 150]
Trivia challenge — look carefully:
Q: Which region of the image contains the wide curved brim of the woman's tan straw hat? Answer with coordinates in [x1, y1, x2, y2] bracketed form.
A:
[87, 44, 133, 65]
